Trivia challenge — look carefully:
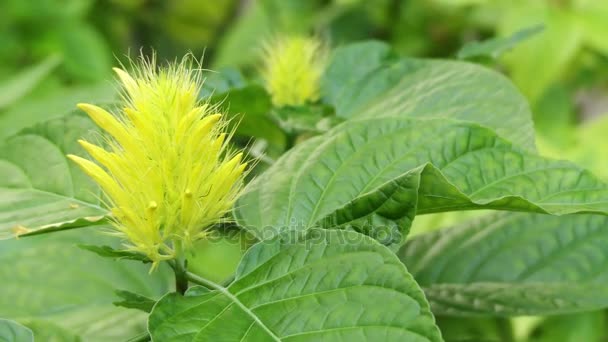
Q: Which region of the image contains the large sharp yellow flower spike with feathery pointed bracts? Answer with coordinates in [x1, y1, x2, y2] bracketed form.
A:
[68, 58, 246, 265]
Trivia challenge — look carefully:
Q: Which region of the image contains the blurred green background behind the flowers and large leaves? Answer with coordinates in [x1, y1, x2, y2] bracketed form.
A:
[0, 0, 608, 341]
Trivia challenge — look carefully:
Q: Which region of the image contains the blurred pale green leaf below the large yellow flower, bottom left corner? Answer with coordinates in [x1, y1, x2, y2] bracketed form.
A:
[0, 229, 170, 341]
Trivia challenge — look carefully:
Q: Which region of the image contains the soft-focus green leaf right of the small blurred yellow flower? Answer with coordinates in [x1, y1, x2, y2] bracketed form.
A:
[322, 42, 534, 150]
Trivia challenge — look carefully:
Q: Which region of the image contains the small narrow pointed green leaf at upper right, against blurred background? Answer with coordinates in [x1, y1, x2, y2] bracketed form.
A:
[456, 25, 544, 59]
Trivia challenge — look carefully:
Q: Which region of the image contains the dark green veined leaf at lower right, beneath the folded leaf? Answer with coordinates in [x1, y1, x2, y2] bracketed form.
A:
[399, 213, 608, 316]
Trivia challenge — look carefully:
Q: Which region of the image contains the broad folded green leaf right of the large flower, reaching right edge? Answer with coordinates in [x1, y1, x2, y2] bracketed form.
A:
[235, 118, 608, 242]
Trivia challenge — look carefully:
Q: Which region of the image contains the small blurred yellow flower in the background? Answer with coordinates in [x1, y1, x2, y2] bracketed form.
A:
[262, 37, 327, 106]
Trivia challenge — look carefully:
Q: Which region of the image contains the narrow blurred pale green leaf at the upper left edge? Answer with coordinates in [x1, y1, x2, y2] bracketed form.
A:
[0, 55, 61, 110]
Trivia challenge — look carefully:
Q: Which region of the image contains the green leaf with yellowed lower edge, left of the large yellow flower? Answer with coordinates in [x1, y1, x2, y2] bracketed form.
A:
[0, 115, 106, 239]
